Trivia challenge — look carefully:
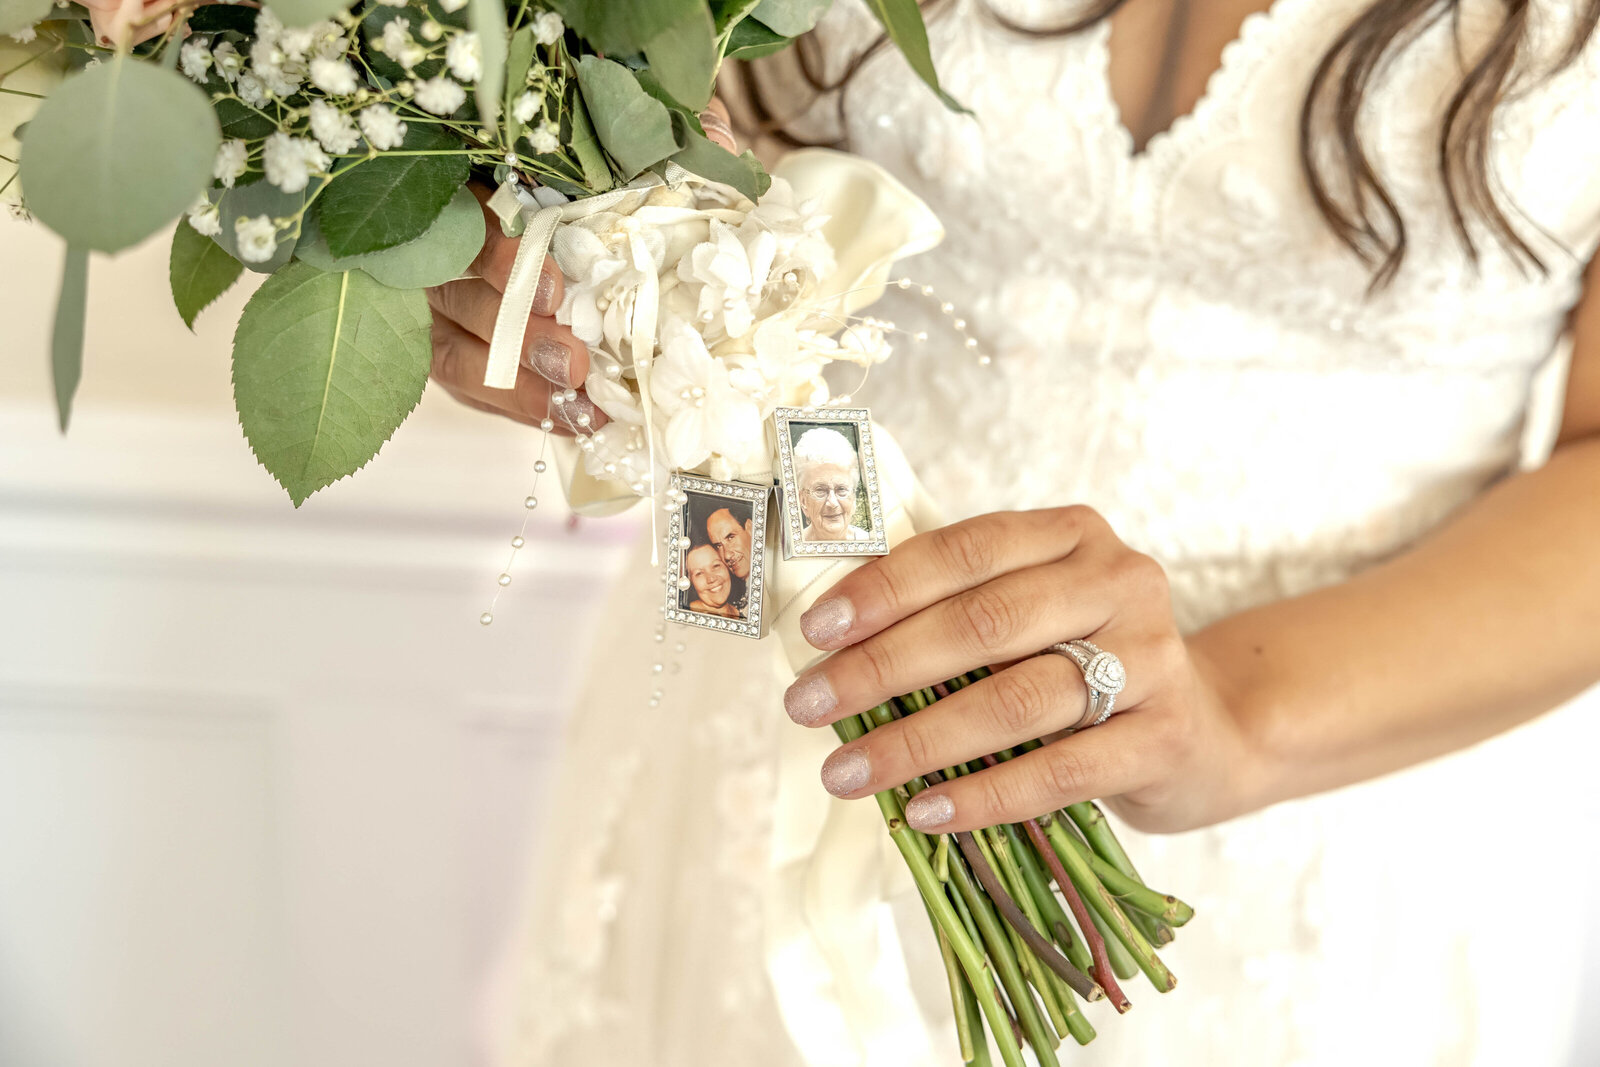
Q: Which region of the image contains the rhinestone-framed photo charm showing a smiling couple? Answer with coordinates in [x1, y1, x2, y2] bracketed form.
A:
[664, 474, 771, 637]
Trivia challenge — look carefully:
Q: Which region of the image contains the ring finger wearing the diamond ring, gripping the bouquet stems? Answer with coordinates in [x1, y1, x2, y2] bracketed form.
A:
[822, 635, 1157, 798]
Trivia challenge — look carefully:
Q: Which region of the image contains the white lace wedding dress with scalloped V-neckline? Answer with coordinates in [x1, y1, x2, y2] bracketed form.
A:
[492, 0, 1600, 1067]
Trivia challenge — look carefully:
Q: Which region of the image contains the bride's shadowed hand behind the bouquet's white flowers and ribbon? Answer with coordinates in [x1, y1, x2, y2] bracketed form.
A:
[427, 101, 738, 435]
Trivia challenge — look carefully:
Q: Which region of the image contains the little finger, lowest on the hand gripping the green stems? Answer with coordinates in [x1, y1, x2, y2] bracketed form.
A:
[906, 710, 1173, 833]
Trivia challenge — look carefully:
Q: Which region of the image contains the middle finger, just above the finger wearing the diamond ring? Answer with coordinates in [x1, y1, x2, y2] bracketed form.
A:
[784, 552, 1139, 726]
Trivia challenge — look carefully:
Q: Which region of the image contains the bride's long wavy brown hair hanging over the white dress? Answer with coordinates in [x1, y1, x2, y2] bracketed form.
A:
[736, 0, 1600, 290]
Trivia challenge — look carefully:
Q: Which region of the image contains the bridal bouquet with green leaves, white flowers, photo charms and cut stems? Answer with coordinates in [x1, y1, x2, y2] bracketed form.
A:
[0, 0, 1190, 1067]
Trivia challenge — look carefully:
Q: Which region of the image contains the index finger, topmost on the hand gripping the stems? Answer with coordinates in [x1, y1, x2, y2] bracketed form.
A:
[800, 506, 1110, 652]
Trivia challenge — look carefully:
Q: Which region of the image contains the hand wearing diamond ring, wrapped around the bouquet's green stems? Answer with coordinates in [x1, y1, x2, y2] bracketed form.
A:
[784, 506, 1262, 832]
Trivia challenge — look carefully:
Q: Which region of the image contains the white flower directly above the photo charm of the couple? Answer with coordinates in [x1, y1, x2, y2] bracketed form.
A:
[650, 318, 763, 470]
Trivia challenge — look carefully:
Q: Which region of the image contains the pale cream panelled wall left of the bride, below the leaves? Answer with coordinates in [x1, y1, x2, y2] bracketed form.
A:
[0, 222, 1600, 1067]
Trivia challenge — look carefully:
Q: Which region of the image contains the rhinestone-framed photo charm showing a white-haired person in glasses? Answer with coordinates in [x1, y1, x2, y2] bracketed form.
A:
[773, 408, 890, 560]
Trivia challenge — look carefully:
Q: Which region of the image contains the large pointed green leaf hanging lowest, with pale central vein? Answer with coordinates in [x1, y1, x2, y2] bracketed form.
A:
[234, 262, 432, 507]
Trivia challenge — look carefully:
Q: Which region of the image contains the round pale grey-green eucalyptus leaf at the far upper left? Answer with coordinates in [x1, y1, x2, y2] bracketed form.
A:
[21, 58, 222, 251]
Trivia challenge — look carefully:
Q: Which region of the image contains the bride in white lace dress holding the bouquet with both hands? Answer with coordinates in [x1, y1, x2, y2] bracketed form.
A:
[434, 0, 1600, 1067]
